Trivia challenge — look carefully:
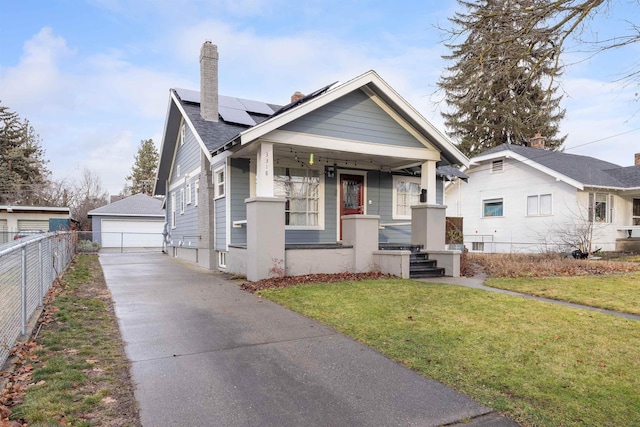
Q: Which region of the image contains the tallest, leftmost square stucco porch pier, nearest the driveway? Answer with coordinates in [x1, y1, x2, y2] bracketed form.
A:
[245, 197, 286, 282]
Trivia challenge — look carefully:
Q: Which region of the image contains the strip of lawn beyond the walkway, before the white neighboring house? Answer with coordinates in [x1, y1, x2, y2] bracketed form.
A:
[485, 273, 640, 314]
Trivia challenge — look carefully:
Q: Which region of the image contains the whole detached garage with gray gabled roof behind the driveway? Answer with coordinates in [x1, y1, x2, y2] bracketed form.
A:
[88, 194, 165, 248]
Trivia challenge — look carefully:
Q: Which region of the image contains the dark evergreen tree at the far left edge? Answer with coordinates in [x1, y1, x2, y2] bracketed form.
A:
[0, 105, 49, 204]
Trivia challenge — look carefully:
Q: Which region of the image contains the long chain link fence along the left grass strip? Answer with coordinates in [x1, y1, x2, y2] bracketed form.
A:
[0, 232, 78, 367]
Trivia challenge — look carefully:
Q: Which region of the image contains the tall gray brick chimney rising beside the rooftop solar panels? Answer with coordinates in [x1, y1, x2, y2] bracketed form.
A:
[200, 40, 218, 122]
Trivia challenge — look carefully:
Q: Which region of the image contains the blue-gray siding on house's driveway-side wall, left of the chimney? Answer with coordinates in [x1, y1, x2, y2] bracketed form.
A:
[166, 122, 202, 248]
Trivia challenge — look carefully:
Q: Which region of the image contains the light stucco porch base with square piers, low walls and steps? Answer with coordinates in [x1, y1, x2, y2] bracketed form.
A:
[226, 197, 461, 281]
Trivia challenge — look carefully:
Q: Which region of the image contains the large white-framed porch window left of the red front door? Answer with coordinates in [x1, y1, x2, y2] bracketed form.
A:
[273, 167, 320, 227]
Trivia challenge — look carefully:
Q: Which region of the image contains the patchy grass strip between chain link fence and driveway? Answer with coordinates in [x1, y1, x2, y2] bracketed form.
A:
[12, 255, 138, 427]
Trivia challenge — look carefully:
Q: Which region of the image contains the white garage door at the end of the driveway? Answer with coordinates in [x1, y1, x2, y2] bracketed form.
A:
[101, 219, 164, 248]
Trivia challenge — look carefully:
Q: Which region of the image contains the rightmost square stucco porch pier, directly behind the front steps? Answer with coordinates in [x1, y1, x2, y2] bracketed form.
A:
[411, 204, 447, 252]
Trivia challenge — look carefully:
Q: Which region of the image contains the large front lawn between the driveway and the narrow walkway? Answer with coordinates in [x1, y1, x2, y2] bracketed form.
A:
[260, 280, 640, 426]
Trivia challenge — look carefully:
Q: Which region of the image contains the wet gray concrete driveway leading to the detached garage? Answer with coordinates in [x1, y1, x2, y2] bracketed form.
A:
[100, 253, 517, 427]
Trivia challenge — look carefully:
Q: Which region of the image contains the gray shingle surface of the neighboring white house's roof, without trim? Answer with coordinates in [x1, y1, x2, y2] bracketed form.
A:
[482, 144, 640, 188]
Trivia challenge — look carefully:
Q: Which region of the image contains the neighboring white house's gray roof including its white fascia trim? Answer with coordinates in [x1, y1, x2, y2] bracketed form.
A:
[471, 144, 640, 189]
